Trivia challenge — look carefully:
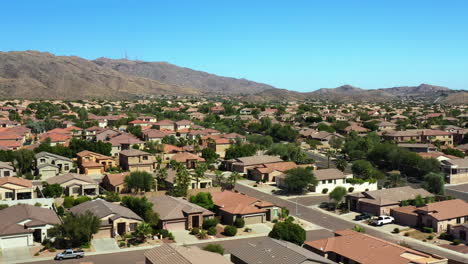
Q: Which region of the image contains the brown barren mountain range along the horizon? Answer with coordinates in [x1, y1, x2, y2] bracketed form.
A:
[0, 51, 468, 103]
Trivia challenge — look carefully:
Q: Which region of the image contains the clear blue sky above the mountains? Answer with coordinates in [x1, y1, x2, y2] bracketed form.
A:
[0, 0, 468, 91]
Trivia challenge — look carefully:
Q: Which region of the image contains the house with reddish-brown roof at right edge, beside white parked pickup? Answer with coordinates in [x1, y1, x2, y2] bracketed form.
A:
[391, 199, 468, 232]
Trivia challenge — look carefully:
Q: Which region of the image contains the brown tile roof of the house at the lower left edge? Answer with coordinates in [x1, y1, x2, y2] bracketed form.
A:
[0, 204, 60, 236]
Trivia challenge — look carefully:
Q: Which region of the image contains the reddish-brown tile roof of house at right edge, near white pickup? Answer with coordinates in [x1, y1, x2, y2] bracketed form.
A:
[417, 199, 468, 221]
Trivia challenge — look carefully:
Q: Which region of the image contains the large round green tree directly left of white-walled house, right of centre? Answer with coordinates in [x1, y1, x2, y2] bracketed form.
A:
[284, 168, 318, 193]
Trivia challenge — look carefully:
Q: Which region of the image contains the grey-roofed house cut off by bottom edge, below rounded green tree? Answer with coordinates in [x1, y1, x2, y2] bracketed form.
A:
[229, 237, 335, 264]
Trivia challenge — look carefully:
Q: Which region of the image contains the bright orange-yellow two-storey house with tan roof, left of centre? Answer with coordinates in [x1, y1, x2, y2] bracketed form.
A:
[76, 150, 116, 175]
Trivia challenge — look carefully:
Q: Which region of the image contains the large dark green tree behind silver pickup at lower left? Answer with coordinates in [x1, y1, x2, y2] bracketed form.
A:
[49, 211, 101, 248]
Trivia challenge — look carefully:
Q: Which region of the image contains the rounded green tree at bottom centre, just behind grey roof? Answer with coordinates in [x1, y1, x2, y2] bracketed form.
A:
[268, 221, 306, 246]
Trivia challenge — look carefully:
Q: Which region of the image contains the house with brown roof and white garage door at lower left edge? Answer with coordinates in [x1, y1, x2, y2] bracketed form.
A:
[0, 204, 60, 249]
